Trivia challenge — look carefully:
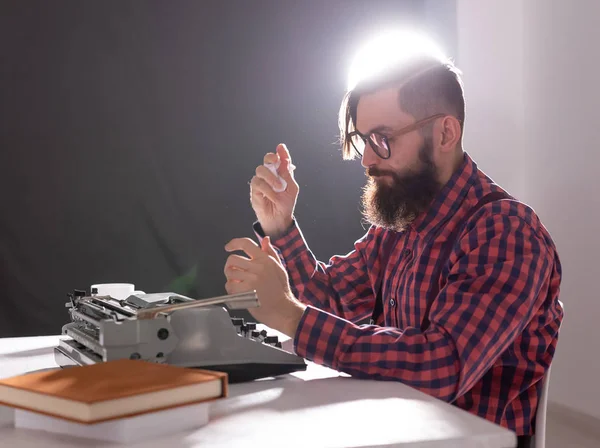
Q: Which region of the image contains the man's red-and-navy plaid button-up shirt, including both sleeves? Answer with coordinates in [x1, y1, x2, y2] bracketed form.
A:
[254, 154, 563, 435]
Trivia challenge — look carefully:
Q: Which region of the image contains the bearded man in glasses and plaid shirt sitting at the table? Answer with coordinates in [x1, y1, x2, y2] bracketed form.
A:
[225, 32, 563, 442]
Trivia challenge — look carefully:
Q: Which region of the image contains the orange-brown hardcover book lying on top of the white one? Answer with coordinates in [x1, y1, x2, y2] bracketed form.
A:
[0, 359, 228, 424]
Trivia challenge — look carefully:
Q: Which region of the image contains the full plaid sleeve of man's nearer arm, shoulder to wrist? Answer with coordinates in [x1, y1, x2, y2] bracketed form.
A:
[294, 215, 554, 401]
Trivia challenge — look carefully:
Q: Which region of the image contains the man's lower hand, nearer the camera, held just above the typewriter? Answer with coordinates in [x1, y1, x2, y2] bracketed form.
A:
[225, 237, 306, 338]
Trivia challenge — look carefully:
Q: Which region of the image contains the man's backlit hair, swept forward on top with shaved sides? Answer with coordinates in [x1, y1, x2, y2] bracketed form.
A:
[339, 55, 465, 160]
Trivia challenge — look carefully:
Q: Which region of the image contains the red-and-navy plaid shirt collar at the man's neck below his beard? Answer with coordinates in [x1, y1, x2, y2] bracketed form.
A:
[411, 152, 477, 237]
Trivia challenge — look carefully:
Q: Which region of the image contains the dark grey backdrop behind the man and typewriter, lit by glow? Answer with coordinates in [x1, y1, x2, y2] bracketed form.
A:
[0, 0, 453, 336]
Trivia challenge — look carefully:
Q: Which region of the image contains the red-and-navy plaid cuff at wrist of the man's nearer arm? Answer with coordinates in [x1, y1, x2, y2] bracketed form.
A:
[294, 305, 353, 369]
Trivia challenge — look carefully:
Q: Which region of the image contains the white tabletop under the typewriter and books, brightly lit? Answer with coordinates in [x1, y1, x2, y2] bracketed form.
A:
[0, 336, 516, 448]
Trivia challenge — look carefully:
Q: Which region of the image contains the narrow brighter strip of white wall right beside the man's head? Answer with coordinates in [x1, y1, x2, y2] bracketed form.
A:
[456, 0, 525, 196]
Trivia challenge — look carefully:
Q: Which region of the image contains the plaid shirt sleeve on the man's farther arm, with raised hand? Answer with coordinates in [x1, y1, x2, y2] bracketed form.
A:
[253, 219, 375, 321]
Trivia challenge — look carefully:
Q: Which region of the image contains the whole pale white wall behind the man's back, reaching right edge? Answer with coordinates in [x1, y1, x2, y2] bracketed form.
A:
[457, 0, 600, 418]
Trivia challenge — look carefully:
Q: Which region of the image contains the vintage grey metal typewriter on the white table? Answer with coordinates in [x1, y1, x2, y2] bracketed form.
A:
[54, 290, 306, 383]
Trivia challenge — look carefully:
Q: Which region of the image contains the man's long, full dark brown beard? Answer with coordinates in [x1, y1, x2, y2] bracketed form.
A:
[361, 140, 441, 232]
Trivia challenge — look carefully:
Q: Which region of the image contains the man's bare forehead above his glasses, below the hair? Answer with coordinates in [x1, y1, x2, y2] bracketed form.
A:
[356, 86, 411, 133]
